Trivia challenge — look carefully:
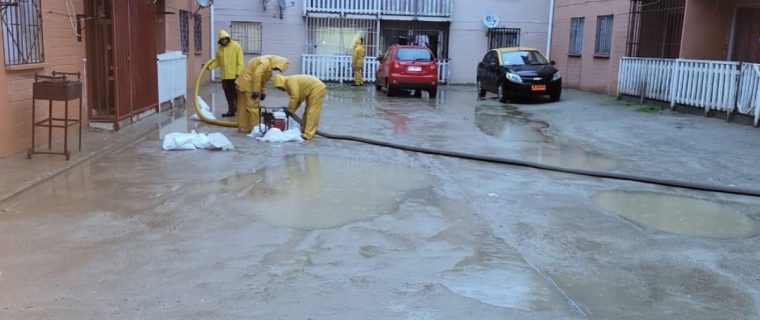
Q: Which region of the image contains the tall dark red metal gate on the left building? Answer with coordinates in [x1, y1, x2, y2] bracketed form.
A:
[85, 0, 158, 130]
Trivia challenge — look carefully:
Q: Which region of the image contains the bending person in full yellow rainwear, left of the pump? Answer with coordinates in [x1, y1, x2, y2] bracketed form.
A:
[235, 55, 290, 132]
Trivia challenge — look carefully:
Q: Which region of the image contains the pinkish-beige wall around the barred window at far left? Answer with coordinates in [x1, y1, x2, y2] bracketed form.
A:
[0, 0, 86, 157]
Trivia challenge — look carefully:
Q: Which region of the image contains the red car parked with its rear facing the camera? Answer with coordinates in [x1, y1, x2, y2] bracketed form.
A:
[375, 44, 438, 98]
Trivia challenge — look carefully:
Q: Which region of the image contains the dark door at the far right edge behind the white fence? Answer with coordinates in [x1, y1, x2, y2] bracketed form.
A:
[732, 8, 760, 63]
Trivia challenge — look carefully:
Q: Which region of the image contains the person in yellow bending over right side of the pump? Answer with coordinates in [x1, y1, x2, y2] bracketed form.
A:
[272, 74, 327, 140]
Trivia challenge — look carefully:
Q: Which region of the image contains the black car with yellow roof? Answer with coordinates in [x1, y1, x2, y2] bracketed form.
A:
[478, 47, 562, 102]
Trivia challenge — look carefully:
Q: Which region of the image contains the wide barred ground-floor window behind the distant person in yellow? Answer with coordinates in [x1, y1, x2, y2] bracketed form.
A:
[306, 17, 378, 57]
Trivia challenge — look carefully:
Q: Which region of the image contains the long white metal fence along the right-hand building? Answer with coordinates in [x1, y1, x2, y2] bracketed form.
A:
[618, 57, 760, 126]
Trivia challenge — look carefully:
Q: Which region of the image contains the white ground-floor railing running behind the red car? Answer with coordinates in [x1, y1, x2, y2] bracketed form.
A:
[301, 54, 450, 83]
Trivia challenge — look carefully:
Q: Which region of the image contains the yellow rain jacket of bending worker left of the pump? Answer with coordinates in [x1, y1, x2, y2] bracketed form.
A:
[235, 55, 290, 93]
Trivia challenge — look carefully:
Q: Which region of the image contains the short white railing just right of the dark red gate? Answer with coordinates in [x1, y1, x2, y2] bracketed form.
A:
[157, 51, 187, 105]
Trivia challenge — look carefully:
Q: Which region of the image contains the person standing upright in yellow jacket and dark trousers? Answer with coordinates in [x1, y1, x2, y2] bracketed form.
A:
[208, 30, 244, 117]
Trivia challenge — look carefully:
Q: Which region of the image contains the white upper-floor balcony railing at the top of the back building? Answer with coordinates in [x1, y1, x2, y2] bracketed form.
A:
[304, 0, 452, 18]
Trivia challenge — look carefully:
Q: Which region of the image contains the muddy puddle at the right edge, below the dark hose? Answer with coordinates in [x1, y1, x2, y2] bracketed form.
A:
[594, 191, 760, 238]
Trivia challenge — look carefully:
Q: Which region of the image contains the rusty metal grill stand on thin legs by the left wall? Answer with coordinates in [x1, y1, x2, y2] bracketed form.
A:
[26, 71, 82, 161]
